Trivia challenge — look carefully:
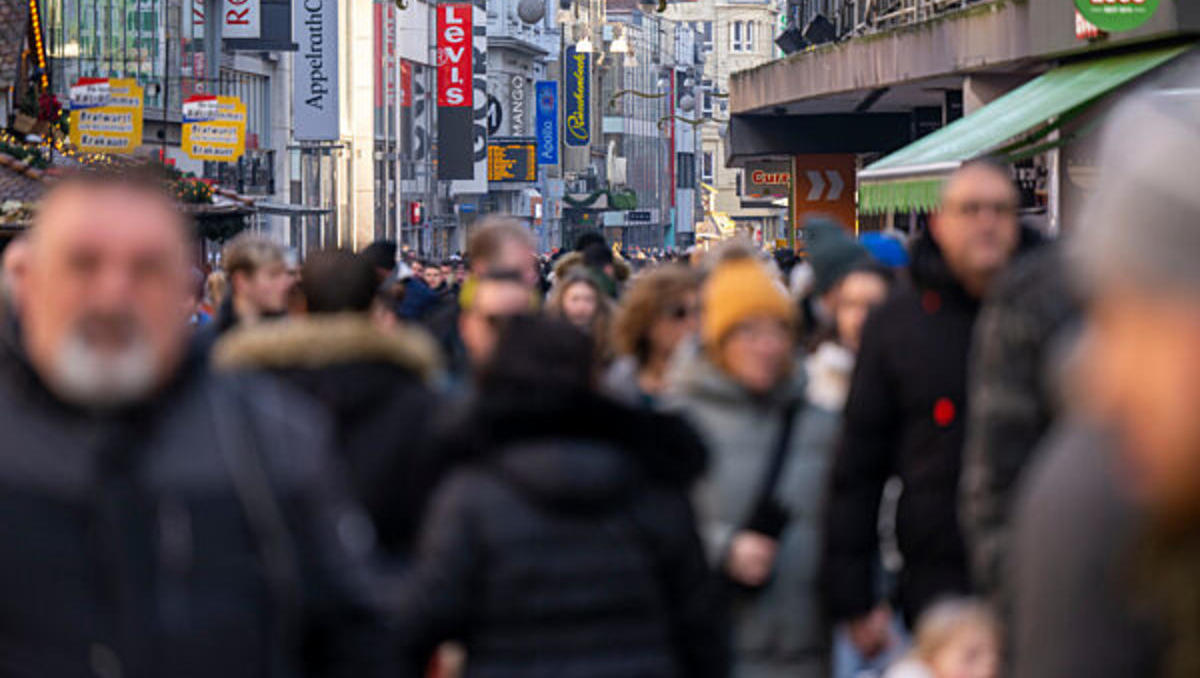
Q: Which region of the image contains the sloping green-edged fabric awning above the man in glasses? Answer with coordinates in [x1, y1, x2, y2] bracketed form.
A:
[858, 46, 1192, 214]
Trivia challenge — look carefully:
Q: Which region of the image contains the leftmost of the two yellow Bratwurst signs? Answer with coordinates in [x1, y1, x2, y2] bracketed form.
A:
[68, 78, 144, 154]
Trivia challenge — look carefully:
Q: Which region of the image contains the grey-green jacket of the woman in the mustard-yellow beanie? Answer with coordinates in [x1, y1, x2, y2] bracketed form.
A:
[666, 353, 839, 678]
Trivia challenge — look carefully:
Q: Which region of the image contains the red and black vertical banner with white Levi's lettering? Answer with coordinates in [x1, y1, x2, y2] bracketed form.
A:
[437, 2, 475, 179]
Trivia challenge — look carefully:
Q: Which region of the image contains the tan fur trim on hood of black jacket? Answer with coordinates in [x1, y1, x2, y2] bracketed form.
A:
[212, 313, 440, 379]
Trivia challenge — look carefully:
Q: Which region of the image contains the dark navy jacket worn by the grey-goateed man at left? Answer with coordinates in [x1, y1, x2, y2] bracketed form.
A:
[0, 326, 385, 678]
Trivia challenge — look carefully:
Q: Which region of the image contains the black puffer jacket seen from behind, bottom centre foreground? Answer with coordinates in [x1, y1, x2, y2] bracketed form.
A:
[401, 392, 728, 678]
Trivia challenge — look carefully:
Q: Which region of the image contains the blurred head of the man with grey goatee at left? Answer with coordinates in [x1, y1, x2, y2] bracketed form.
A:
[18, 175, 192, 406]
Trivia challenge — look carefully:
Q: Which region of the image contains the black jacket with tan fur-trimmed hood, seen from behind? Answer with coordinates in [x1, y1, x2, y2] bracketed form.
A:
[212, 313, 438, 556]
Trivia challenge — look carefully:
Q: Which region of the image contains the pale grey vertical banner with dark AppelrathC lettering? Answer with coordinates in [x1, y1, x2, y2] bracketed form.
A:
[292, 0, 340, 142]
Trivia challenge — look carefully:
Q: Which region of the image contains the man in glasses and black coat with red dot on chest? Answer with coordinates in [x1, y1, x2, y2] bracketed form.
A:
[823, 160, 1039, 656]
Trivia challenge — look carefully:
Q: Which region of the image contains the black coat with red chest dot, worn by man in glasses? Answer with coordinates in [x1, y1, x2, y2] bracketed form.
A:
[823, 225, 1039, 623]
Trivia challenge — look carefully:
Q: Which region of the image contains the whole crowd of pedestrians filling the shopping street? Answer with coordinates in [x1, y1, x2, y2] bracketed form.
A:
[0, 90, 1200, 678]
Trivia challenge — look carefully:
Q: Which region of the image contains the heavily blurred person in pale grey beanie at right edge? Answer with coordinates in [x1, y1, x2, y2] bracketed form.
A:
[1013, 90, 1200, 678]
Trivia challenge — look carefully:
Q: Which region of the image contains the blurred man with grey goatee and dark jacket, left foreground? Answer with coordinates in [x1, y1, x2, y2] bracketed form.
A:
[0, 174, 382, 678]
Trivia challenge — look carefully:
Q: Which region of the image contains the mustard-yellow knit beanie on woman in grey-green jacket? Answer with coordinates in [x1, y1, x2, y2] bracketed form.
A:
[701, 259, 796, 347]
